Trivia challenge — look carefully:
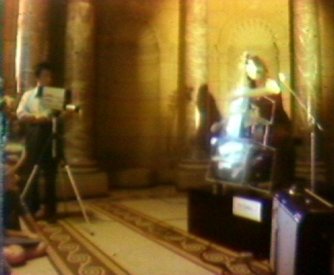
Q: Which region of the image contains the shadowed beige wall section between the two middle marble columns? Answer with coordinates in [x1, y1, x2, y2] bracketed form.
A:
[96, 0, 179, 183]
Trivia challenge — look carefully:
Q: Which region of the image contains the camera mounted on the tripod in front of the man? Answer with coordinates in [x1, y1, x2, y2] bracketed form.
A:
[37, 86, 81, 112]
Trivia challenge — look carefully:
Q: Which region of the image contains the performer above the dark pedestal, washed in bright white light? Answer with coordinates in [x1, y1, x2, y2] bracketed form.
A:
[211, 53, 294, 188]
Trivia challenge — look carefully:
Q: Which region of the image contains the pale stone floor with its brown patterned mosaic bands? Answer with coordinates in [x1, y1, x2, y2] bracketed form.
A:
[14, 188, 272, 275]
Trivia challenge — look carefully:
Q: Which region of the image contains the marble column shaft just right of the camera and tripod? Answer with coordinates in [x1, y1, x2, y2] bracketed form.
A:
[65, 0, 95, 166]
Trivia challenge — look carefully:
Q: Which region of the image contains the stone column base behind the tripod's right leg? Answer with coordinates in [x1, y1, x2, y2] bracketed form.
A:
[57, 167, 109, 199]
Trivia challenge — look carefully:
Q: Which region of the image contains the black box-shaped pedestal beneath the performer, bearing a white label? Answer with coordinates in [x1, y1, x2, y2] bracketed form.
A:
[188, 188, 272, 259]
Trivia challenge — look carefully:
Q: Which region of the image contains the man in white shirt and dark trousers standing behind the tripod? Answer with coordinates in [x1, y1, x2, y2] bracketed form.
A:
[16, 63, 58, 220]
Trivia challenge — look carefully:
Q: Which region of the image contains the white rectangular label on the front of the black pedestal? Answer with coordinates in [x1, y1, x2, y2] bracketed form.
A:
[233, 197, 262, 222]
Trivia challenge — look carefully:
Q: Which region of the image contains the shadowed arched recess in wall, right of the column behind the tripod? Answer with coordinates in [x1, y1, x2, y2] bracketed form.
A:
[96, 1, 160, 177]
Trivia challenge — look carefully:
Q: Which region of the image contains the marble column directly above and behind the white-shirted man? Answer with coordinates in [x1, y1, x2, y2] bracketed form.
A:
[16, 0, 50, 93]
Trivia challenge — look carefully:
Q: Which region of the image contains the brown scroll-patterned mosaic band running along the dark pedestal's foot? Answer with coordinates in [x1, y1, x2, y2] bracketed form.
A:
[89, 200, 271, 275]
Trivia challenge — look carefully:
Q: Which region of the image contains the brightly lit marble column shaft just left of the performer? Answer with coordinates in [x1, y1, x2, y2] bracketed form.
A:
[181, 0, 208, 157]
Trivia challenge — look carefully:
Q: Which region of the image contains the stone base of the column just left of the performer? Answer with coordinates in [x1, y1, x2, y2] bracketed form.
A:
[176, 160, 209, 190]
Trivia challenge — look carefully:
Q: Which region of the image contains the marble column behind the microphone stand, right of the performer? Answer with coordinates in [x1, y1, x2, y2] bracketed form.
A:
[291, 0, 324, 188]
